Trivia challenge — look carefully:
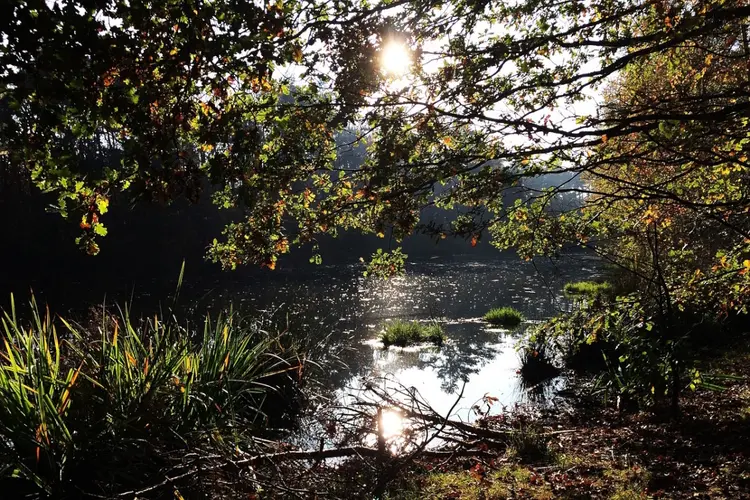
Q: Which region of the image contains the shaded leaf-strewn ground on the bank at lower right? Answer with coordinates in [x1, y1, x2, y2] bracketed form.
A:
[390, 354, 750, 500]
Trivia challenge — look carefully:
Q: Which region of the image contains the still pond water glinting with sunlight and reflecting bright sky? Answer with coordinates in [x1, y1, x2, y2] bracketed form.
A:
[188, 254, 601, 420]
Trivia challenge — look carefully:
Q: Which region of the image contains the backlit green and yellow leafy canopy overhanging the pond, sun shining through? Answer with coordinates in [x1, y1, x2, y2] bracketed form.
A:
[0, 0, 750, 282]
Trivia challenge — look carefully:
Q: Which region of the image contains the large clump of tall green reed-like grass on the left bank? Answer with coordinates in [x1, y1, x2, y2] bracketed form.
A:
[0, 299, 298, 498]
